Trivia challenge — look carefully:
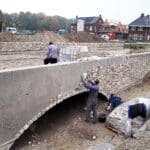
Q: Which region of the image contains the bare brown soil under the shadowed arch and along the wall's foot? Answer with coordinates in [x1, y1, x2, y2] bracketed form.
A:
[12, 81, 150, 150]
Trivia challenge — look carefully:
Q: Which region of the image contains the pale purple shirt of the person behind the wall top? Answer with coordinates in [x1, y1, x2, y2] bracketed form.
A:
[47, 45, 59, 59]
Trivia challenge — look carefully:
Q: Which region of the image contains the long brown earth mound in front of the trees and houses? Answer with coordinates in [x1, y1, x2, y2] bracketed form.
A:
[0, 31, 106, 43]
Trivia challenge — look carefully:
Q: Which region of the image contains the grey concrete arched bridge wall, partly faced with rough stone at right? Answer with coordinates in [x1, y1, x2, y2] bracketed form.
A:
[0, 53, 150, 149]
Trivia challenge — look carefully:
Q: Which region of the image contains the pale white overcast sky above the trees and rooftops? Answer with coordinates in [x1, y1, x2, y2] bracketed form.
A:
[0, 0, 150, 24]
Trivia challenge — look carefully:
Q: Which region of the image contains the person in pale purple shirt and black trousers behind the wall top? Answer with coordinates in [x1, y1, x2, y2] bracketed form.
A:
[44, 42, 59, 65]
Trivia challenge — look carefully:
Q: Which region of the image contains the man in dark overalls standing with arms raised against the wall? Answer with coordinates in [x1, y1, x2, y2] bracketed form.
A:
[82, 73, 99, 123]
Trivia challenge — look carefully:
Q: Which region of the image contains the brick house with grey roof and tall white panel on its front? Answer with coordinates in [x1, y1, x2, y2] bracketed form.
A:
[70, 15, 104, 34]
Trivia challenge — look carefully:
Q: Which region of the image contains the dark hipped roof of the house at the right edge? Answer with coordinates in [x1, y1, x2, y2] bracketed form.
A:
[129, 14, 150, 27]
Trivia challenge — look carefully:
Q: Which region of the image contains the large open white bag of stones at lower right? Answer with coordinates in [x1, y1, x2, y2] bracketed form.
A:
[106, 97, 150, 135]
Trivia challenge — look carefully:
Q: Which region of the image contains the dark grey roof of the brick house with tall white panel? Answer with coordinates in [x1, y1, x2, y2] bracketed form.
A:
[72, 17, 99, 24]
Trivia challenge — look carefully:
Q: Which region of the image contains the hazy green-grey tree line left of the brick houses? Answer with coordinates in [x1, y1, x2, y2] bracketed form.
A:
[2, 12, 72, 31]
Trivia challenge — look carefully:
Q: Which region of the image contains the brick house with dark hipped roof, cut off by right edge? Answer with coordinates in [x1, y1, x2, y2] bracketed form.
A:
[128, 13, 150, 40]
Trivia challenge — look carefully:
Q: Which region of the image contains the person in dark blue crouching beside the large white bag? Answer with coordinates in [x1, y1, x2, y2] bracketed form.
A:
[107, 94, 122, 112]
